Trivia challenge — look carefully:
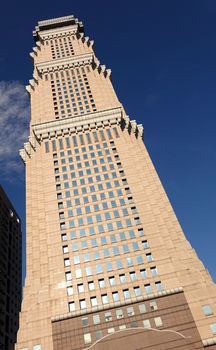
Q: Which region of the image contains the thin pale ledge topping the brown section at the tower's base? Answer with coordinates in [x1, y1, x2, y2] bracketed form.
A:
[51, 287, 183, 322]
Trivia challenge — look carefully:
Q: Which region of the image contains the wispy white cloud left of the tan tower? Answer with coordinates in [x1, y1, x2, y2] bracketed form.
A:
[0, 81, 30, 176]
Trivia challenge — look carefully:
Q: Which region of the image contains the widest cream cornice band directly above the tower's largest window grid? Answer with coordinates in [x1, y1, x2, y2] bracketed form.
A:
[32, 107, 122, 140]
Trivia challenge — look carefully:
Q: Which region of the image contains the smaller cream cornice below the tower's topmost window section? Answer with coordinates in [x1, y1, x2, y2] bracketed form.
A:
[35, 53, 94, 73]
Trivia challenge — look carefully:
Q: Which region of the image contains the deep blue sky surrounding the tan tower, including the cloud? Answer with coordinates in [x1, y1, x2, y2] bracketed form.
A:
[0, 0, 216, 280]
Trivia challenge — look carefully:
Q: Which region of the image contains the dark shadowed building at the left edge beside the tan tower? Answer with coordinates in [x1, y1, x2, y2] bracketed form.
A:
[0, 185, 22, 350]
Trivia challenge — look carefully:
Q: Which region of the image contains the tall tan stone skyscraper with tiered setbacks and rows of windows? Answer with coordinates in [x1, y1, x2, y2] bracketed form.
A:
[16, 16, 216, 350]
